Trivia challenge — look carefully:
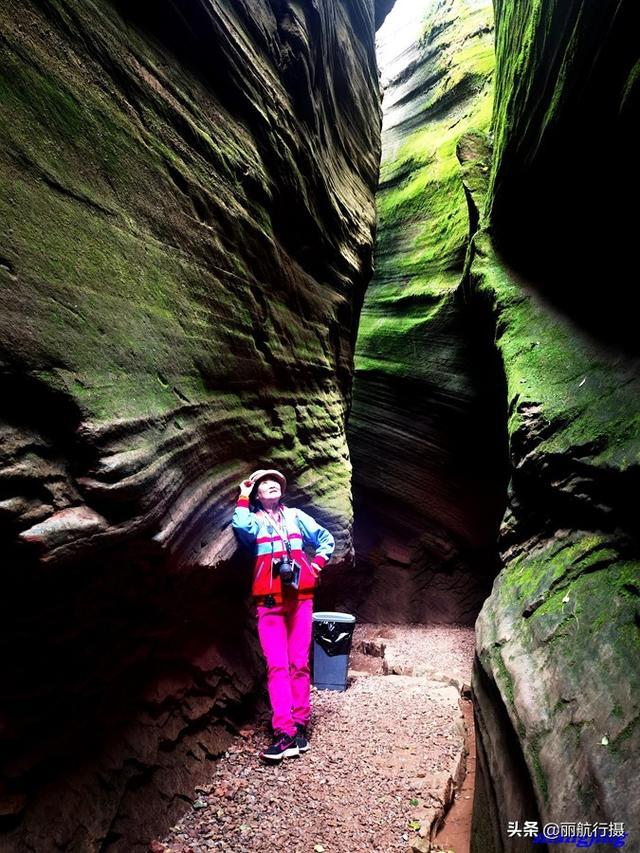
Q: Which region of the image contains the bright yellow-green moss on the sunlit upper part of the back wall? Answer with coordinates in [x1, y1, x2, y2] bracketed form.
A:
[356, 3, 493, 380]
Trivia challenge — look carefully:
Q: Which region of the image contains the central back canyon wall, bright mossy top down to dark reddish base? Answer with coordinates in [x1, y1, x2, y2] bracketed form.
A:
[349, 0, 506, 624]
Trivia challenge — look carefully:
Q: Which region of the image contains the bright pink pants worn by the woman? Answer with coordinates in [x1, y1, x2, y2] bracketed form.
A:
[258, 595, 313, 735]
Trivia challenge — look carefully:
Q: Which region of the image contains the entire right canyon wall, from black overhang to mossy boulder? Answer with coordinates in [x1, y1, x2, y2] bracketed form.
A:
[468, 2, 640, 853]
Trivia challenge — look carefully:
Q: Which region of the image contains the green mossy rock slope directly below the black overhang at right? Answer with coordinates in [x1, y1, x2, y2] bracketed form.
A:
[471, 235, 640, 471]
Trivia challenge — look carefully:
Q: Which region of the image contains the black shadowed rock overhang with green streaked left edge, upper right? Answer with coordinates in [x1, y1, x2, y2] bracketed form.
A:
[491, 2, 639, 355]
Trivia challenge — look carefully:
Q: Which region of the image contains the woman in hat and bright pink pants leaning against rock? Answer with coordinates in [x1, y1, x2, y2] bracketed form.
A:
[231, 469, 335, 761]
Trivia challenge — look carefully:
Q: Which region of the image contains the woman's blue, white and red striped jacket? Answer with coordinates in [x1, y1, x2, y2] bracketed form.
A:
[231, 497, 335, 604]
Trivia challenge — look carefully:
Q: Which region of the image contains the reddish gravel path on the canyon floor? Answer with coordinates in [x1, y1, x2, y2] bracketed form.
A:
[150, 625, 474, 853]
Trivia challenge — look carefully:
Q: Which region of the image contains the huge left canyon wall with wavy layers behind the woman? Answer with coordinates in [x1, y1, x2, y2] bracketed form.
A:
[0, 0, 380, 851]
